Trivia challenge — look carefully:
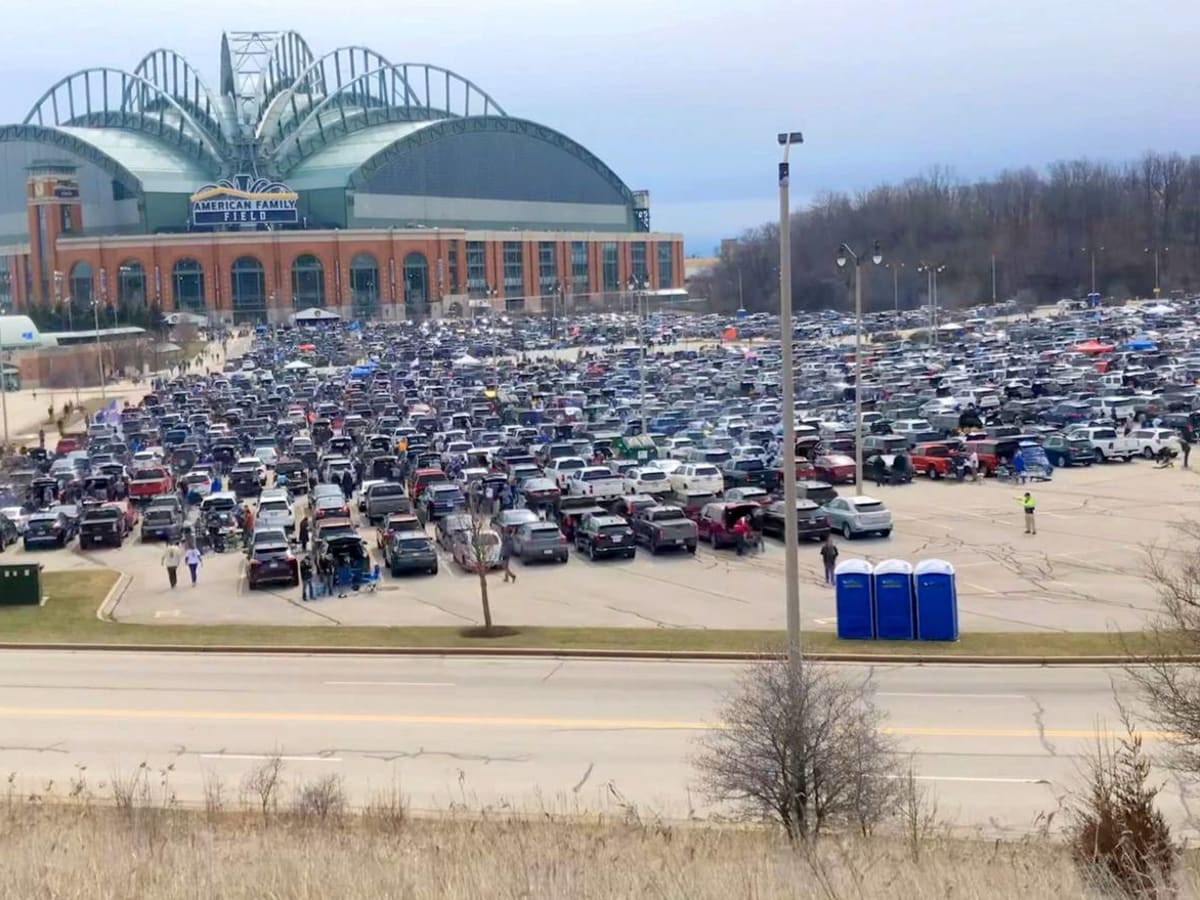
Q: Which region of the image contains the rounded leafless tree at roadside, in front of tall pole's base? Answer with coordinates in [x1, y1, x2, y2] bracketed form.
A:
[696, 660, 900, 840]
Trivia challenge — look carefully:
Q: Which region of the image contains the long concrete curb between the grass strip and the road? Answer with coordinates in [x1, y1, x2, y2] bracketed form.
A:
[0, 643, 1171, 667]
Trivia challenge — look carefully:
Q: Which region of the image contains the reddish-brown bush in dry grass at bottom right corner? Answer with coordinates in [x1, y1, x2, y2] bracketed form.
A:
[1068, 720, 1177, 899]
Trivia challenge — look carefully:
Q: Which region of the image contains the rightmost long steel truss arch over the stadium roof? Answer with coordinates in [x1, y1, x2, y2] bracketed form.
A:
[264, 62, 506, 166]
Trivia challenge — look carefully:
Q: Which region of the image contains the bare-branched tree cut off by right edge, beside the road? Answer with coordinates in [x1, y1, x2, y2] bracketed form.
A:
[1127, 520, 1200, 776]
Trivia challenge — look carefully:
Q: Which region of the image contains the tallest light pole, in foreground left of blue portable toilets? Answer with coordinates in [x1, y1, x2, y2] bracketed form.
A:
[778, 131, 804, 667]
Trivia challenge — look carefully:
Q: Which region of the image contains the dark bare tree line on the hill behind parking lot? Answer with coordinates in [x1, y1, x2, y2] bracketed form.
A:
[692, 152, 1200, 312]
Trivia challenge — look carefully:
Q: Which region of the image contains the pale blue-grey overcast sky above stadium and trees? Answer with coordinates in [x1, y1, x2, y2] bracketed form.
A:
[0, 0, 1200, 253]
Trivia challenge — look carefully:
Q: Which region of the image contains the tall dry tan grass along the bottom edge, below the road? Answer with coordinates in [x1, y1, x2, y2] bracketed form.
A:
[0, 804, 1132, 900]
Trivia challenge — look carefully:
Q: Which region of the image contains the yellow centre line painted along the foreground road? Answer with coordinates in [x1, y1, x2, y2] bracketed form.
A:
[0, 707, 1174, 740]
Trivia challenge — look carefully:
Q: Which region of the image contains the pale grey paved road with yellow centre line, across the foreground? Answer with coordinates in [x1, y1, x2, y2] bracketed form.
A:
[0, 652, 1188, 833]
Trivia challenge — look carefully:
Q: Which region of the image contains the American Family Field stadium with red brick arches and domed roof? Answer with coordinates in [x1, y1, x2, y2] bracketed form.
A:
[0, 31, 684, 323]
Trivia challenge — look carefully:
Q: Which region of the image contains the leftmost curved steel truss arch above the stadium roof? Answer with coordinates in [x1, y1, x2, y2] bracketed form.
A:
[23, 67, 222, 169]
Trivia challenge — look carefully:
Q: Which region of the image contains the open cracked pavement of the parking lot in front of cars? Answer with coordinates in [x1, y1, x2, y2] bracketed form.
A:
[23, 460, 1185, 631]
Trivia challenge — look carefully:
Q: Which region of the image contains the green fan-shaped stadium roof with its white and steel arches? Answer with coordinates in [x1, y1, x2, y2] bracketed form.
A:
[9, 31, 630, 197]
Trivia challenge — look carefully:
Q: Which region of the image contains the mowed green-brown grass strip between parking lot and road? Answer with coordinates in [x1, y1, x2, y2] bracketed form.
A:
[0, 570, 1171, 658]
